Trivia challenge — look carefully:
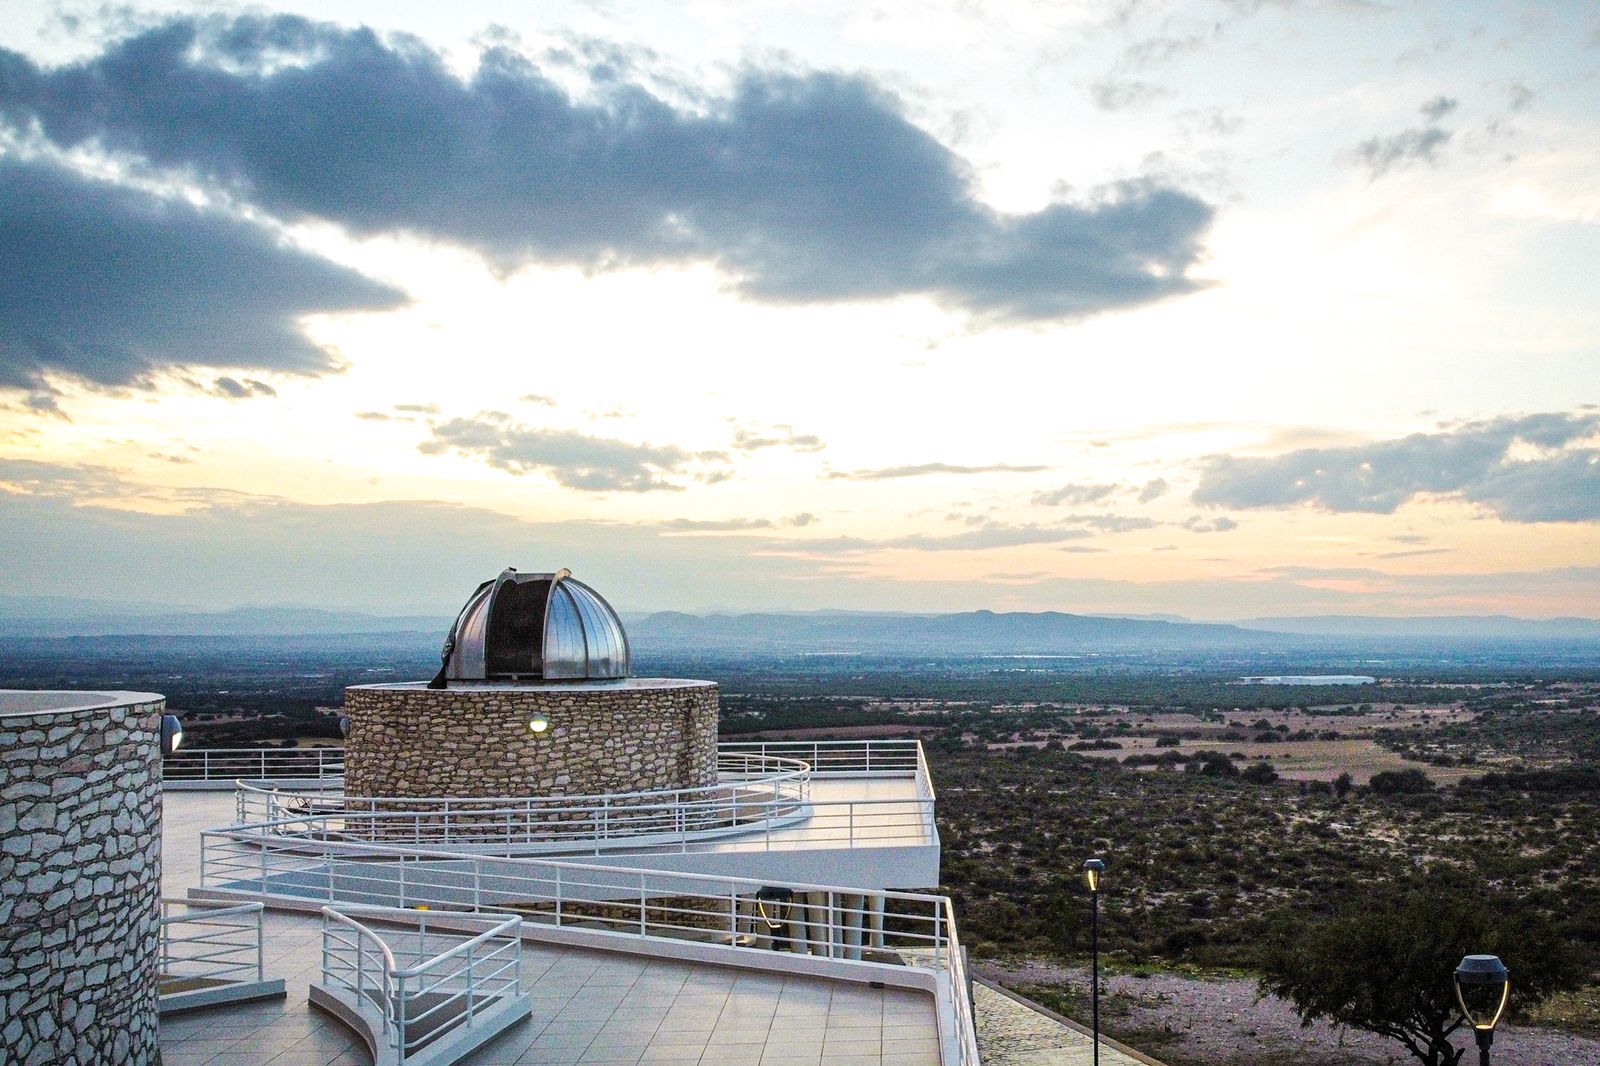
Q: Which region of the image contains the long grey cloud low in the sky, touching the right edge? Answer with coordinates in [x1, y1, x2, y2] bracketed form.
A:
[1194, 413, 1600, 522]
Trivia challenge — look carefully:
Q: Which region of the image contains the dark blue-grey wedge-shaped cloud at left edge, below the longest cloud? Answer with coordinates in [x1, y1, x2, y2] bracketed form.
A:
[0, 156, 402, 397]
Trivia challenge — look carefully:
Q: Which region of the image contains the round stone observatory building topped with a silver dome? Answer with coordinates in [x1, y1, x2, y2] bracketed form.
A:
[344, 570, 717, 799]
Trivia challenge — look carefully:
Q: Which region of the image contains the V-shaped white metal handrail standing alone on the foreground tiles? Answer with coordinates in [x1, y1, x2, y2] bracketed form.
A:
[322, 906, 522, 1061]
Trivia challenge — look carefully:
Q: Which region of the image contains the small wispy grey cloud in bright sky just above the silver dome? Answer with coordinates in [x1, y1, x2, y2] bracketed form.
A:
[418, 411, 715, 493]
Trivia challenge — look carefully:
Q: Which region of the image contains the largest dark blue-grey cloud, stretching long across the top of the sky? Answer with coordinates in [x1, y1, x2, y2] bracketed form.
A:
[0, 16, 1213, 320]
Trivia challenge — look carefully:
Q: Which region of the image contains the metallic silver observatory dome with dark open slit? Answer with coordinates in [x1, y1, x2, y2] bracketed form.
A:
[430, 568, 632, 688]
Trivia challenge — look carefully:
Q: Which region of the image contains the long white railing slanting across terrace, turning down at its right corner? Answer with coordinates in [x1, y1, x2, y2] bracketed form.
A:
[202, 828, 978, 1066]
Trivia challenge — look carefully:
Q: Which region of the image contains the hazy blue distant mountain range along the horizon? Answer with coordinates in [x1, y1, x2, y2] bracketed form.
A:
[0, 595, 1600, 643]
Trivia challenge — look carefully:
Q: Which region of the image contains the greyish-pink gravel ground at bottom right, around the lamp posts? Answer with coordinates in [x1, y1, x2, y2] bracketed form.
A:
[973, 962, 1600, 1066]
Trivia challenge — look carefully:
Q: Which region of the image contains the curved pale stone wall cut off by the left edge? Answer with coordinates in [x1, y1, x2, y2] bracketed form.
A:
[0, 691, 165, 1066]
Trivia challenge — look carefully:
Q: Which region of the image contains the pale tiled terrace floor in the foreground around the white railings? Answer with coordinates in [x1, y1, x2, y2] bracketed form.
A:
[162, 792, 939, 1066]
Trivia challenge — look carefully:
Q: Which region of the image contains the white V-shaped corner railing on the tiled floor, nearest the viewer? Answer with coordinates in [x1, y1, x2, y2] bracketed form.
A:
[322, 906, 526, 1063]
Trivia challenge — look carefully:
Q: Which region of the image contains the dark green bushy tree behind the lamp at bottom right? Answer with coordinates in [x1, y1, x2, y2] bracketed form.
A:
[1261, 869, 1589, 1066]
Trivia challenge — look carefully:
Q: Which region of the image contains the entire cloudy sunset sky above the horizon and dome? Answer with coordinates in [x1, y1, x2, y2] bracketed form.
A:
[0, 0, 1600, 619]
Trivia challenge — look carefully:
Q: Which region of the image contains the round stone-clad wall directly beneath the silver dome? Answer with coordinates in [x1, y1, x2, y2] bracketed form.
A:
[344, 677, 717, 797]
